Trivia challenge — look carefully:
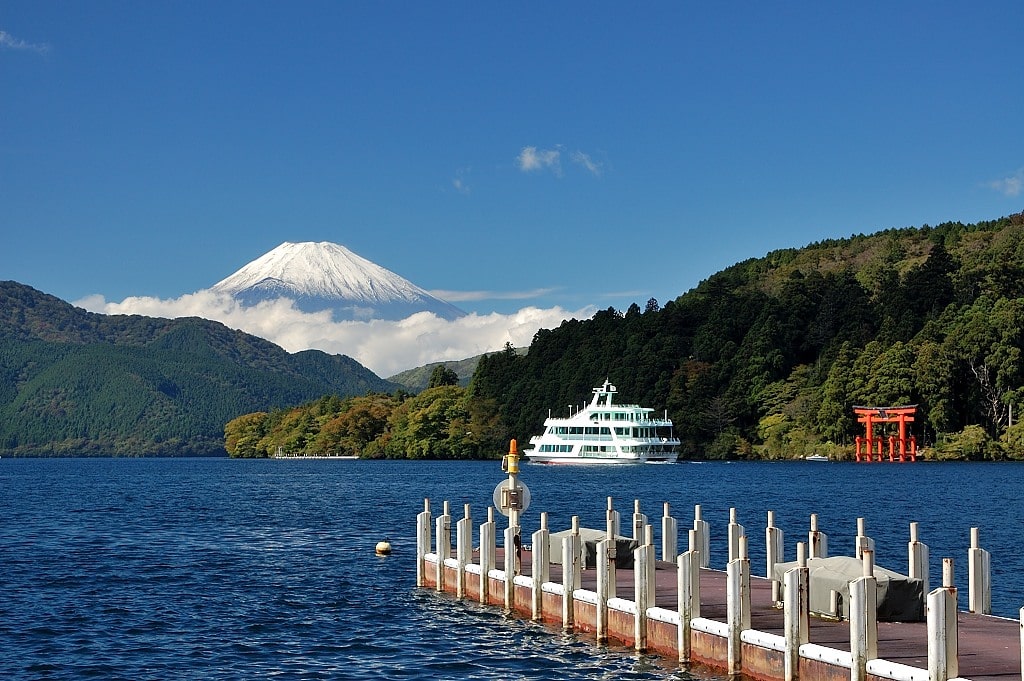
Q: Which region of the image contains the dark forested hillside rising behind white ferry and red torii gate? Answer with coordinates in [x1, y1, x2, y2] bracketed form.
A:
[471, 214, 1024, 459]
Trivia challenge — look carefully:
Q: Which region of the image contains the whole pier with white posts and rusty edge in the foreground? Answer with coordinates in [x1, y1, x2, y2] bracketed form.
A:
[417, 493, 1024, 681]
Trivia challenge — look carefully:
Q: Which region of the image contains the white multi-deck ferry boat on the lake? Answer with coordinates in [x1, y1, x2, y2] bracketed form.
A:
[523, 380, 679, 464]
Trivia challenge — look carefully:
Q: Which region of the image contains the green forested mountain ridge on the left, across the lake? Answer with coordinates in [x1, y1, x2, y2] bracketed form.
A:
[0, 282, 395, 456]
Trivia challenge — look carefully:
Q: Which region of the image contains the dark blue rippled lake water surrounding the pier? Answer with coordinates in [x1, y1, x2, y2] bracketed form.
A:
[0, 459, 1024, 680]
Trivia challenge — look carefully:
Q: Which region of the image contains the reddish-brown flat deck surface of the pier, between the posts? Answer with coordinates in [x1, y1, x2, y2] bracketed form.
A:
[498, 548, 1021, 681]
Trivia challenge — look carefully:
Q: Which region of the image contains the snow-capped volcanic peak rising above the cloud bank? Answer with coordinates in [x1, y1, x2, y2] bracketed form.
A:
[210, 242, 466, 321]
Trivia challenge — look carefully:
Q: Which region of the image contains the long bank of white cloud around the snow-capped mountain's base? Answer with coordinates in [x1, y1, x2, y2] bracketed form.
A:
[75, 291, 594, 378]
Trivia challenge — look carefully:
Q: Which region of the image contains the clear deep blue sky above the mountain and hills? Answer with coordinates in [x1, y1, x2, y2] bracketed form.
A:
[0, 0, 1024, 372]
